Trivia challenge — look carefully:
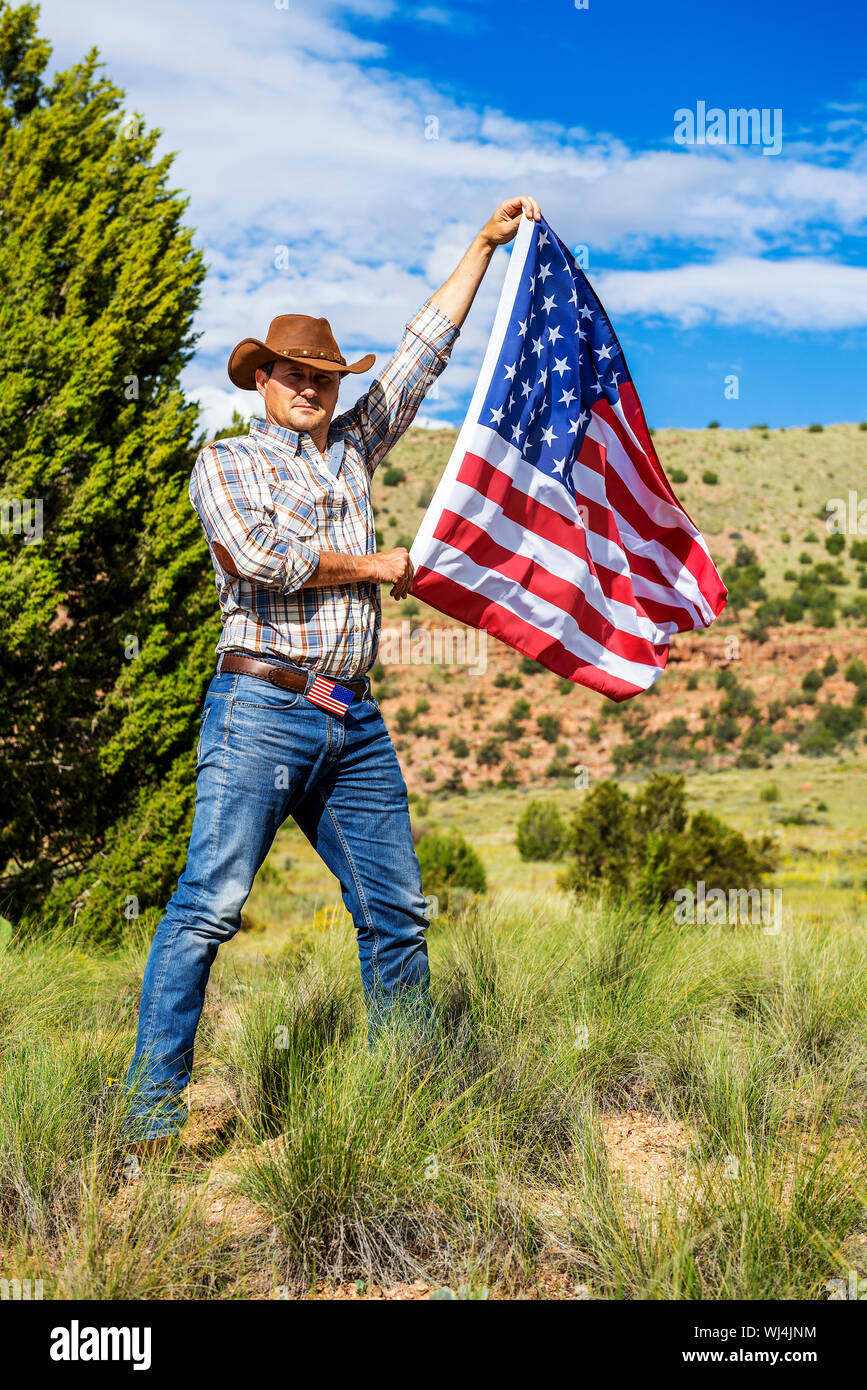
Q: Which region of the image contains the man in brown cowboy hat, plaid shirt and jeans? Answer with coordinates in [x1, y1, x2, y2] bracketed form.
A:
[126, 197, 540, 1147]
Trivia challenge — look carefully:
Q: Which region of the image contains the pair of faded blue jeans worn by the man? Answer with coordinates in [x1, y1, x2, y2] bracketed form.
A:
[126, 674, 429, 1138]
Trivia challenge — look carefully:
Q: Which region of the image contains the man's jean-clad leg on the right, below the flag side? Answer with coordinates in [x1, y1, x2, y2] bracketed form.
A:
[293, 699, 429, 1037]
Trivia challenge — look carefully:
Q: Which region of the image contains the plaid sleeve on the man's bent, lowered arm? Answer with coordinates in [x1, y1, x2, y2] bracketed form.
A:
[189, 443, 320, 594]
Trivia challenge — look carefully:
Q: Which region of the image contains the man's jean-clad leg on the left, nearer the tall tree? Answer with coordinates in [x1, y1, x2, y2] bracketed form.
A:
[120, 676, 317, 1140]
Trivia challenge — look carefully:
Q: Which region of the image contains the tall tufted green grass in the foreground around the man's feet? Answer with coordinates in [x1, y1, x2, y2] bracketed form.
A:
[0, 891, 867, 1300]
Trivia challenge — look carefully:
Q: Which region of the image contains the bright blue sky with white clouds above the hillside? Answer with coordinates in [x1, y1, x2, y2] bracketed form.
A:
[33, 0, 867, 430]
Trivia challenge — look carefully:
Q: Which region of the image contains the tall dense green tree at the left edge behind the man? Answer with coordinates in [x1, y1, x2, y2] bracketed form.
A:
[0, 0, 212, 934]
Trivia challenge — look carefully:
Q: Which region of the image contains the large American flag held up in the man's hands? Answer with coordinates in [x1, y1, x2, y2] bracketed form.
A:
[410, 218, 725, 701]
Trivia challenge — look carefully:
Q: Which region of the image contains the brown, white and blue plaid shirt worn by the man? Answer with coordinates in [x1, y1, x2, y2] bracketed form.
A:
[189, 303, 459, 680]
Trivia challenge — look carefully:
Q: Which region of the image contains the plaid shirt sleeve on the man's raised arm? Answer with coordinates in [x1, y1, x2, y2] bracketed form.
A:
[340, 302, 460, 473]
